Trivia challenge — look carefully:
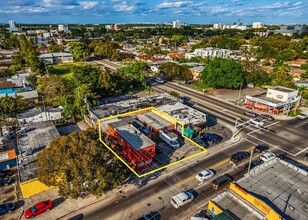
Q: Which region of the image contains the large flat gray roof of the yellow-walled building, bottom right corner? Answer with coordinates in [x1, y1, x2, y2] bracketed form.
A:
[237, 159, 308, 220]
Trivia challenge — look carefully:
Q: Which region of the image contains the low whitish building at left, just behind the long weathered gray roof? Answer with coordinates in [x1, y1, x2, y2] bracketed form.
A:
[17, 106, 62, 125]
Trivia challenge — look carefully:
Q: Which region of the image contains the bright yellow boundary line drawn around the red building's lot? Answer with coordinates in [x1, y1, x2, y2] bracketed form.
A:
[97, 107, 207, 178]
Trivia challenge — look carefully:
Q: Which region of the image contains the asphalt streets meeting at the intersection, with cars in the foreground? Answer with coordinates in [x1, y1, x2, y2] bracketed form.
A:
[63, 85, 308, 219]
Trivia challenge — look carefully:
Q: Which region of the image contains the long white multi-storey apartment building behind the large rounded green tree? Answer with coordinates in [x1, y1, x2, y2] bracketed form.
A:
[185, 47, 233, 60]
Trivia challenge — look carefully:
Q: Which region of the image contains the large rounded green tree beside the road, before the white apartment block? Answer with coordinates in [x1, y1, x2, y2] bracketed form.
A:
[201, 58, 246, 89]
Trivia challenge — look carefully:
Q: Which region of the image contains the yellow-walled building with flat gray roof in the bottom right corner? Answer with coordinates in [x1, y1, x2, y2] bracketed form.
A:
[208, 158, 308, 220]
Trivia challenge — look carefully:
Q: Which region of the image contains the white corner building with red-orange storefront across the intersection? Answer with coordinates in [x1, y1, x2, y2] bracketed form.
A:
[245, 86, 299, 114]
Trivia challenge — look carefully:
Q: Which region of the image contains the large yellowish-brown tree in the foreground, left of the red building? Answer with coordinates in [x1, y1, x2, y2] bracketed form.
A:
[37, 129, 130, 199]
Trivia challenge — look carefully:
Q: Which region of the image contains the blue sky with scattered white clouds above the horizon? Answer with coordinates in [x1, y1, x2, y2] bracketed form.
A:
[0, 0, 308, 24]
